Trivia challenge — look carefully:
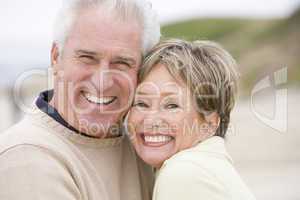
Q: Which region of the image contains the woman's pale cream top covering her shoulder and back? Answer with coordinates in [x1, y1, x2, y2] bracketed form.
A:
[153, 136, 255, 200]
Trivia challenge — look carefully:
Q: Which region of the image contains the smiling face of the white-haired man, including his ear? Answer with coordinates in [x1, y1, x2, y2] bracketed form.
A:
[52, 8, 142, 137]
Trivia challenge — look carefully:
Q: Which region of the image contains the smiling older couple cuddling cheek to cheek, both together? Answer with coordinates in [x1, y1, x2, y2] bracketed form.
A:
[0, 0, 255, 200]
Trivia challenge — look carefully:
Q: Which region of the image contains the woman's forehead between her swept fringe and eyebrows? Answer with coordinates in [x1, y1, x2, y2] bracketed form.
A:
[137, 64, 187, 94]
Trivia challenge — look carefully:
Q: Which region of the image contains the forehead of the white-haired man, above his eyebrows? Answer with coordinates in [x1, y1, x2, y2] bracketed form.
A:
[67, 8, 142, 54]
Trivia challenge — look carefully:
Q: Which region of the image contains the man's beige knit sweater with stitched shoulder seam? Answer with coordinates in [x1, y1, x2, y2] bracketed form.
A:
[0, 108, 153, 200]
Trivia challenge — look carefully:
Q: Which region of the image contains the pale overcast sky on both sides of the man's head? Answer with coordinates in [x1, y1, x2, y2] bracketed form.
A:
[0, 0, 300, 83]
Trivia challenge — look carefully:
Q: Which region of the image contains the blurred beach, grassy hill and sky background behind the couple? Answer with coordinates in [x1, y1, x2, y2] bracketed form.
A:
[0, 0, 300, 200]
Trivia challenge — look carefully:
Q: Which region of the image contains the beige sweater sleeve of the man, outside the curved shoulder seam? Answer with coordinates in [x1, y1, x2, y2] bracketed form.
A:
[0, 134, 81, 199]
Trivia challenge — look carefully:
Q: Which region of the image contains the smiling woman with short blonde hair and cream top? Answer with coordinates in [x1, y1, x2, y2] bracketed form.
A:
[128, 40, 255, 200]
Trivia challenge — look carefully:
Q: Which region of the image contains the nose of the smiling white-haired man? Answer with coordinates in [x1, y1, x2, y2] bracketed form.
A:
[92, 62, 114, 92]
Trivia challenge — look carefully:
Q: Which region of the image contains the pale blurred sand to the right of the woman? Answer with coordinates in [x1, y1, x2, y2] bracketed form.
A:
[227, 89, 300, 200]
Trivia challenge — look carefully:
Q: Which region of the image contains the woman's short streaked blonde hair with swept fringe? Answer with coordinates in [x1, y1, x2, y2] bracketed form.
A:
[139, 39, 238, 137]
